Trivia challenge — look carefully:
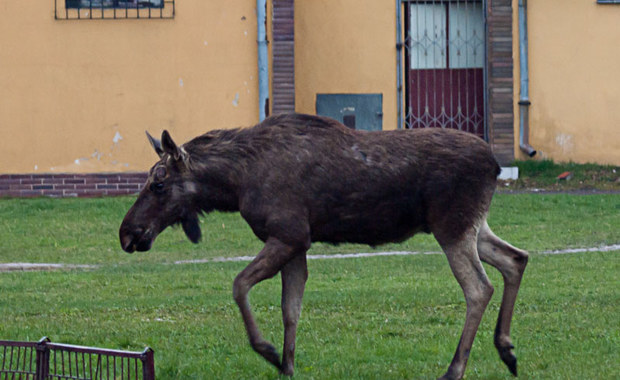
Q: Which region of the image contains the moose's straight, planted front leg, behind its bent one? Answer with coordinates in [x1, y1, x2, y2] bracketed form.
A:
[280, 254, 308, 376]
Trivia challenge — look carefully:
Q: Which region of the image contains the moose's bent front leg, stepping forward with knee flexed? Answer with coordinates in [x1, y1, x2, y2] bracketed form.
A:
[233, 238, 305, 370]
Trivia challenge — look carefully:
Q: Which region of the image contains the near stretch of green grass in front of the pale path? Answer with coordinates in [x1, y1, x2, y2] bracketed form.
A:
[0, 252, 620, 379]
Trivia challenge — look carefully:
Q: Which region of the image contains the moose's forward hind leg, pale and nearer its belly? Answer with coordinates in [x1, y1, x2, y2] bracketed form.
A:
[435, 228, 493, 380]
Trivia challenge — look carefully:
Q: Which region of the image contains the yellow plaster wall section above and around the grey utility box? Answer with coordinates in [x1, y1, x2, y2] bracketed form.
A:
[295, 0, 397, 129]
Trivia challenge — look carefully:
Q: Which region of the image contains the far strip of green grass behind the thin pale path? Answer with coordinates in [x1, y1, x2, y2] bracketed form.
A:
[0, 194, 620, 264]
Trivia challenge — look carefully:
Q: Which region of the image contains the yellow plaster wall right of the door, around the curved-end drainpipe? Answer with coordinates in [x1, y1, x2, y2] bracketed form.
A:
[513, 0, 620, 165]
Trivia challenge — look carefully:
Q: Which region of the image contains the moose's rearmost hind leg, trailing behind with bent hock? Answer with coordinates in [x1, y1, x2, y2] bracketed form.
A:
[478, 222, 528, 376]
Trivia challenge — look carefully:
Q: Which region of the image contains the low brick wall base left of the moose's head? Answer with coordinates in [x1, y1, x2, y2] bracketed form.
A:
[0, 173, 147, 198]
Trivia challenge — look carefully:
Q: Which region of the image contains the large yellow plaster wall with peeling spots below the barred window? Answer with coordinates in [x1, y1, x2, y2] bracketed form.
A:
[0, 0, 258, 173]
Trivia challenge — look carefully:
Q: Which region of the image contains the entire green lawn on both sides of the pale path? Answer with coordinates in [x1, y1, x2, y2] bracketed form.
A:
[0, 194, 620, 379]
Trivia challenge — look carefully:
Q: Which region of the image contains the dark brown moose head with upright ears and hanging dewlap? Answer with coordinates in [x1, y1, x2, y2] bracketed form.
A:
[119, 131, 201, 253]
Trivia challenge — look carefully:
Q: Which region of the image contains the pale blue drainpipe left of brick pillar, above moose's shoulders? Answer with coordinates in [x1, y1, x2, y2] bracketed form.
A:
[256, 0, 269, 121]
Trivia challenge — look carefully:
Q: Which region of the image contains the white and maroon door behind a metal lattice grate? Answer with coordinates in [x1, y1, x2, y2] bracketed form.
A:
[404, 0, 486, 138]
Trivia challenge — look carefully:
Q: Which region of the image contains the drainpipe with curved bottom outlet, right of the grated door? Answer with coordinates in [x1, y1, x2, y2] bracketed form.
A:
[519, 0, 536, 157]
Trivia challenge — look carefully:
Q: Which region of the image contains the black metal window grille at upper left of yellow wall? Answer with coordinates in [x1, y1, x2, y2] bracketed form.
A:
[54, 0, 175, 20]
